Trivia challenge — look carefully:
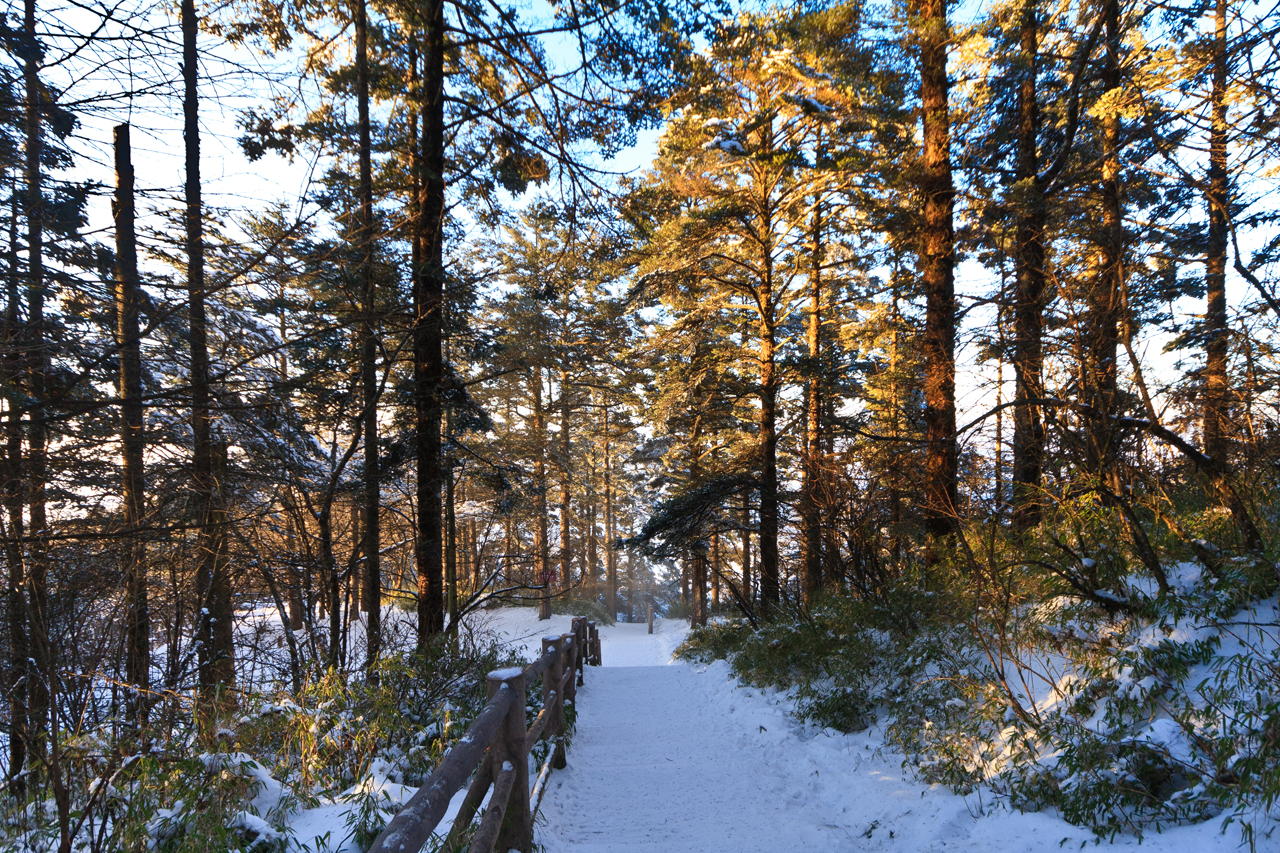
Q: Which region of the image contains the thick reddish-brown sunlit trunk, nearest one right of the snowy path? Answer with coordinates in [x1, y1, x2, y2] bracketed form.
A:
[915, 0, 959, 548]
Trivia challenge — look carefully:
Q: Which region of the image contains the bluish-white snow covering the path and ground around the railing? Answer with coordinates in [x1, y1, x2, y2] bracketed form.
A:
[280, 608, 1280, 853]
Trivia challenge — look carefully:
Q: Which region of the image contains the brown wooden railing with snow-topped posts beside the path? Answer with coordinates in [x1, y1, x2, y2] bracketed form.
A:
[369, 617, 600, 853]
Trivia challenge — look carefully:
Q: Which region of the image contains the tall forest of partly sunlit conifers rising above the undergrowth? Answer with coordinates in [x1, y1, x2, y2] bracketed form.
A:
[0, 0, 1280, 849]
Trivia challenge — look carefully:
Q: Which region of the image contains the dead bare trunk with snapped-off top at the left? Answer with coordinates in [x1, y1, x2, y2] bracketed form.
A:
[111, 124, 151, 729]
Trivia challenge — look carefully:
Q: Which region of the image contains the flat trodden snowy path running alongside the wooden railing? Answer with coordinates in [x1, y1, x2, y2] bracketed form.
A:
[529, 665, 860, 853]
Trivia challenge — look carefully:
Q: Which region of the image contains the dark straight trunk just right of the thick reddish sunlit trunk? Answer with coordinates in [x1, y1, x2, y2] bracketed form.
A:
[1011, 0, 1046, 529]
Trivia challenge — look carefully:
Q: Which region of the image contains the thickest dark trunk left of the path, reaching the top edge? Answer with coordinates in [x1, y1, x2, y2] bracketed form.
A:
[413, 0, 445, 637]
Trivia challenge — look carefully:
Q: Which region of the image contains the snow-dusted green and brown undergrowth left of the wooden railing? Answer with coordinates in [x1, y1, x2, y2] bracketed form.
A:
[0, 625, 524, 853]
